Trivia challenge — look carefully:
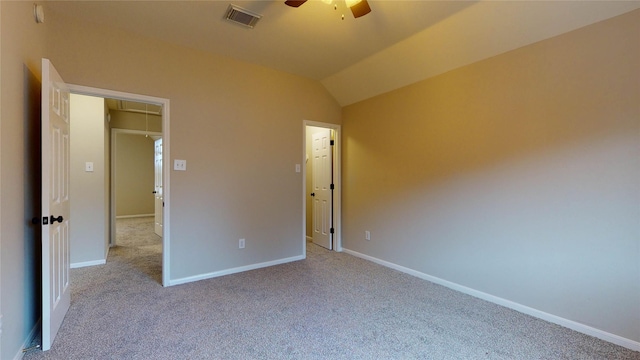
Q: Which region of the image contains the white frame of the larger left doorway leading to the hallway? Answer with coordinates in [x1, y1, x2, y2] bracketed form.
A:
[68, 84, 171, 286]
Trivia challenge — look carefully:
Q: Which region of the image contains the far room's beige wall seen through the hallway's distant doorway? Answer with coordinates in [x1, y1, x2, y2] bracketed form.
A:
[114, 133, 155, 216]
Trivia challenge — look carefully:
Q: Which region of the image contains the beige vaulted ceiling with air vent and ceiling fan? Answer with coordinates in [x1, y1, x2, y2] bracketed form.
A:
[47, 0, 640, 106]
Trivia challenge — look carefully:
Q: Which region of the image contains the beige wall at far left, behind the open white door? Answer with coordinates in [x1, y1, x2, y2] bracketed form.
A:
[0, 1, 46, 359]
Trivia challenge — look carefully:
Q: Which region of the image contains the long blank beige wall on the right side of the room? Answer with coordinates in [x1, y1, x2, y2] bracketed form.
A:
[343, 11, 640, 342]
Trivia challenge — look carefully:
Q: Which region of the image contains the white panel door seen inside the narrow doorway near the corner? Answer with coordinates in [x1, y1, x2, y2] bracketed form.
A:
[311, 129, 333, 249]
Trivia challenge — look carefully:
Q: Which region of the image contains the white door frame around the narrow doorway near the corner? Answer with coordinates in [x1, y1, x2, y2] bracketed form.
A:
[302, 120, 342, 256]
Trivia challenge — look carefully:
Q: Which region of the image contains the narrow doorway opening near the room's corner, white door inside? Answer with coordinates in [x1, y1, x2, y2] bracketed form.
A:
[303, 120, 342, 253]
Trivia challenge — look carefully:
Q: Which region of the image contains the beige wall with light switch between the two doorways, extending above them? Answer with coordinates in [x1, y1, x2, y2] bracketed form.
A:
[45, 7, 341, 280]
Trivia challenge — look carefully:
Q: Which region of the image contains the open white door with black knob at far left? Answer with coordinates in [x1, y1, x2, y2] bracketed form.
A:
[41, 59, 71, 350]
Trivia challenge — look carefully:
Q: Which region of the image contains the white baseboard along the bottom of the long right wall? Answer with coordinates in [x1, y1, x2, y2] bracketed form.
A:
[343, 249, 640, 351]
